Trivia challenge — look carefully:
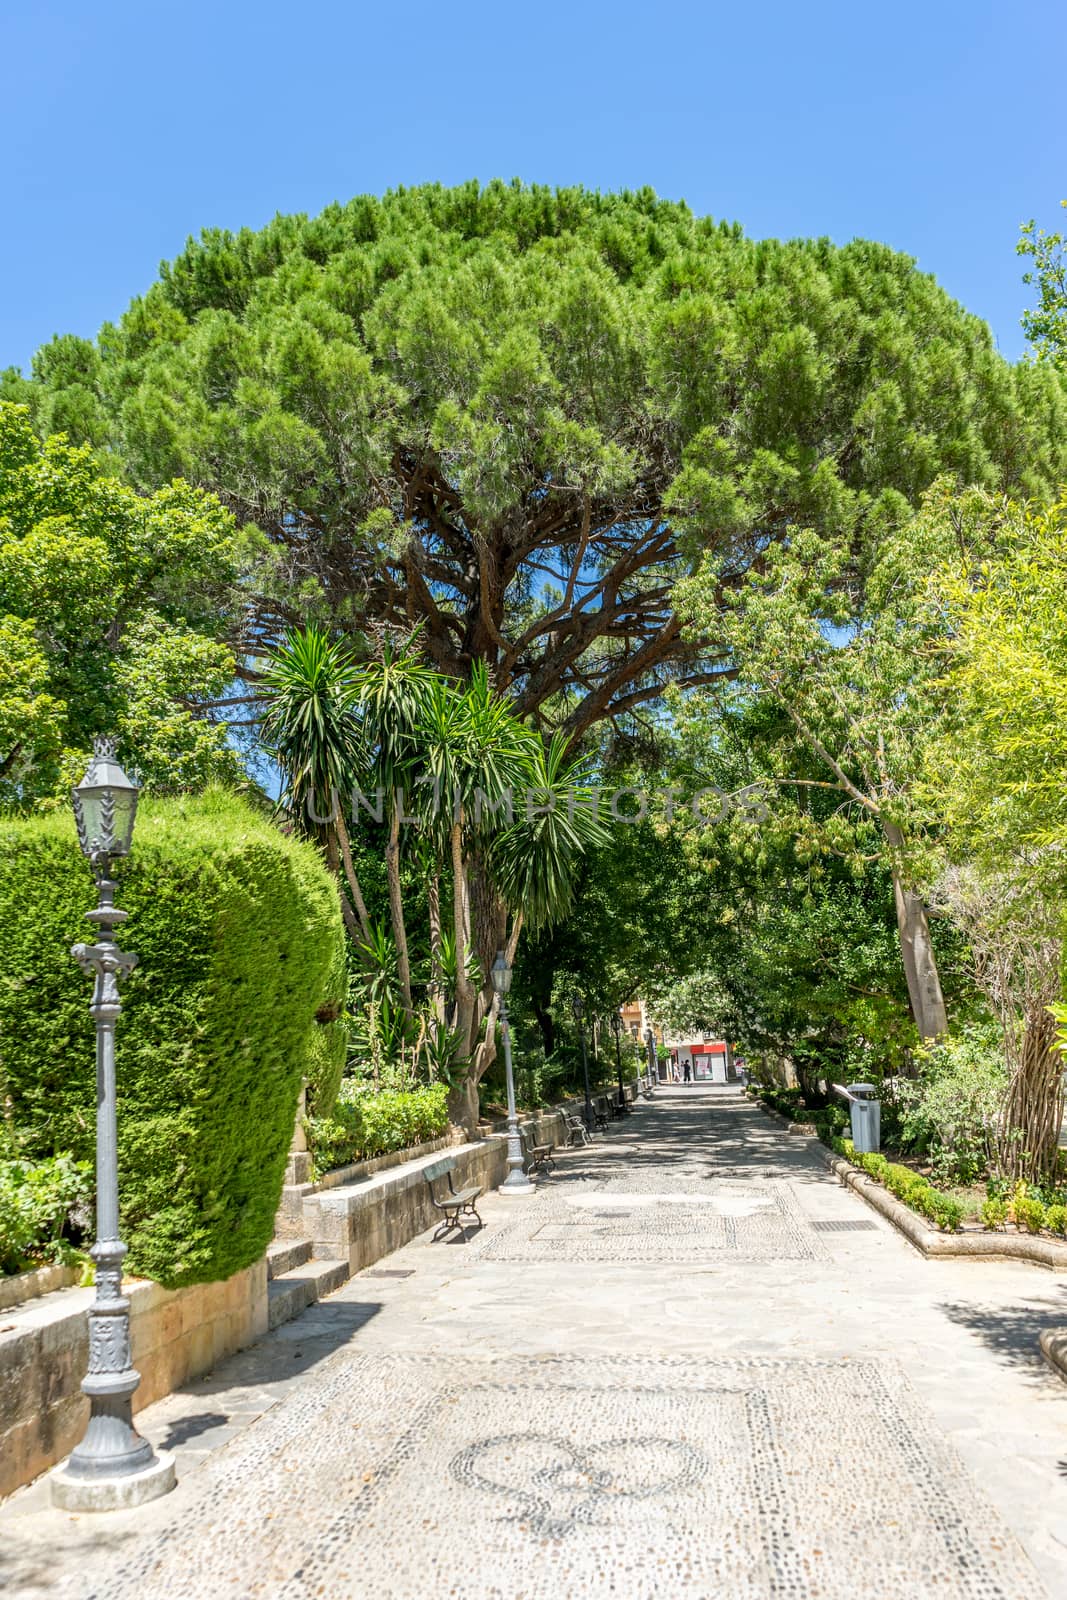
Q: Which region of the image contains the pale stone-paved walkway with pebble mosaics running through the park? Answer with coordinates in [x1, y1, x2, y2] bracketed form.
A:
[0, 1086, 1067, 1600]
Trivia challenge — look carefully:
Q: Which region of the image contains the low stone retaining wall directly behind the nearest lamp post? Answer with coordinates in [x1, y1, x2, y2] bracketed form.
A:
[0, 1261, 267, 1496]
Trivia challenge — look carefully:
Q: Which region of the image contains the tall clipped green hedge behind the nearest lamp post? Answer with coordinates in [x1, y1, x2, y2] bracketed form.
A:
[0, 792, 344, 1286]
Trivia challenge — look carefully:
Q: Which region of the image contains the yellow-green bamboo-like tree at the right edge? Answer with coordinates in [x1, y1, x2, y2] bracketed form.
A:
[928, 494, 1067, 1179]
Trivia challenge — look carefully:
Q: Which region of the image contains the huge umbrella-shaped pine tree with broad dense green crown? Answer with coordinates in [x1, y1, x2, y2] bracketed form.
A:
[8, 182, 1067, 733]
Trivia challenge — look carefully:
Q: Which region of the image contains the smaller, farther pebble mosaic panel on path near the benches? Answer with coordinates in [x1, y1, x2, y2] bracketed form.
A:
[469, 1166, 825, 1266]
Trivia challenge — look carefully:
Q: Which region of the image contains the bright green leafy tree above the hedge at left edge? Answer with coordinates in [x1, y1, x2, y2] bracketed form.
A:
[0, 403, 248, 802]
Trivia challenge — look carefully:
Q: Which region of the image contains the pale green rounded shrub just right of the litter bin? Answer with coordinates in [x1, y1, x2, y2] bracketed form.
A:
[896, 1026, 1008, 1184]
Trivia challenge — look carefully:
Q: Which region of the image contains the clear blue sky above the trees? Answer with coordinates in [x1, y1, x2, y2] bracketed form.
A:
[0, 0, 1067, 366]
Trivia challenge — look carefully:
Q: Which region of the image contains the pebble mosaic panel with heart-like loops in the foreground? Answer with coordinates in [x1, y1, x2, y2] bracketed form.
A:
[80, 1354, 1041, 1600]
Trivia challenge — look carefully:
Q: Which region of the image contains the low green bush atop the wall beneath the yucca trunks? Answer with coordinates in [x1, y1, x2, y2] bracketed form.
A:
[307, 1083, 448, 1174]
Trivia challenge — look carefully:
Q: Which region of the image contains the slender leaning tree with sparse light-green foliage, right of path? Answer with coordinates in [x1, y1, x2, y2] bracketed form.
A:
[683, 480, 1023, 1038]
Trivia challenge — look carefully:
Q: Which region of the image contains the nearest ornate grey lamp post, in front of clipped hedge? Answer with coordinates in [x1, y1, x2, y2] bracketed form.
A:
[51, 739, 174, 1510]
